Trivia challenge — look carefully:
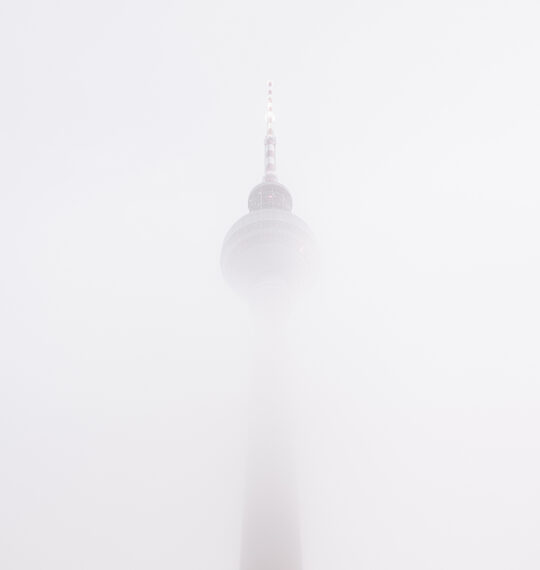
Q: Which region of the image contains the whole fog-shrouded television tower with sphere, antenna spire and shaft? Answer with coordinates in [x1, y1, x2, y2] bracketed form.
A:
[221, 83, 315, 570]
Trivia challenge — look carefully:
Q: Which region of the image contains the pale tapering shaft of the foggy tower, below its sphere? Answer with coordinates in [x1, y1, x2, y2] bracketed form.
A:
[240, 298, 301, 570]
